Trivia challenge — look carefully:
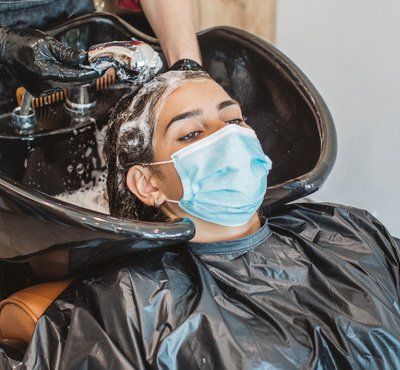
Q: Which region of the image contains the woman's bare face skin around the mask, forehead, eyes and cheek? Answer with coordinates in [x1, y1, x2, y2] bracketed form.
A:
[127, 79, 249, 217]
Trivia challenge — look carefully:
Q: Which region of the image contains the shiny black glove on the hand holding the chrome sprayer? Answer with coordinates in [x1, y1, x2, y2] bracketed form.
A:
[0, 28, 101, 96]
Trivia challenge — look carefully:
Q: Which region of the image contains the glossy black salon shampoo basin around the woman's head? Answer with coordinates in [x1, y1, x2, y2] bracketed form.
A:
[0, 13, 336, 270]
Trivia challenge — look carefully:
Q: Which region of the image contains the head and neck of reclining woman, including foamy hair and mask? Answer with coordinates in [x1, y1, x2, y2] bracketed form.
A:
[105, 71, 272, 242]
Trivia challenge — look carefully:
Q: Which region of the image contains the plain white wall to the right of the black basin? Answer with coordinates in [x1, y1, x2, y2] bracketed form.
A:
[276, 0, 400, 237]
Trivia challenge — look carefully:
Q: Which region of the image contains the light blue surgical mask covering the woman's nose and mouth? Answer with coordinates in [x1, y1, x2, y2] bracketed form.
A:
[144, 124, 272, 226]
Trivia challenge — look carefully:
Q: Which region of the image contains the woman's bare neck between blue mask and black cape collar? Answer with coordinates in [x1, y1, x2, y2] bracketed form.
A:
[190, 213, 261, 243]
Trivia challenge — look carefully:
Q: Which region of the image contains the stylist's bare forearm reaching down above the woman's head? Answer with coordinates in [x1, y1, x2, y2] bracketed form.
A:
[140, 0, 201, 66]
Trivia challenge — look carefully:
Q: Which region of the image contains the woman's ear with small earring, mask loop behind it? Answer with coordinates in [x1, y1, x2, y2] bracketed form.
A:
[126, 165, 162, 206]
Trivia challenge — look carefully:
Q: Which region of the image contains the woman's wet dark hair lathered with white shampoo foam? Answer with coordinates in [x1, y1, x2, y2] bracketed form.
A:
[103, 71, 212, 221]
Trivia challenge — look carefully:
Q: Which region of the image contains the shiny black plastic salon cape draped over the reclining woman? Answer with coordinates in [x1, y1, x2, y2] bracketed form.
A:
[0, 203, 400, 370]
